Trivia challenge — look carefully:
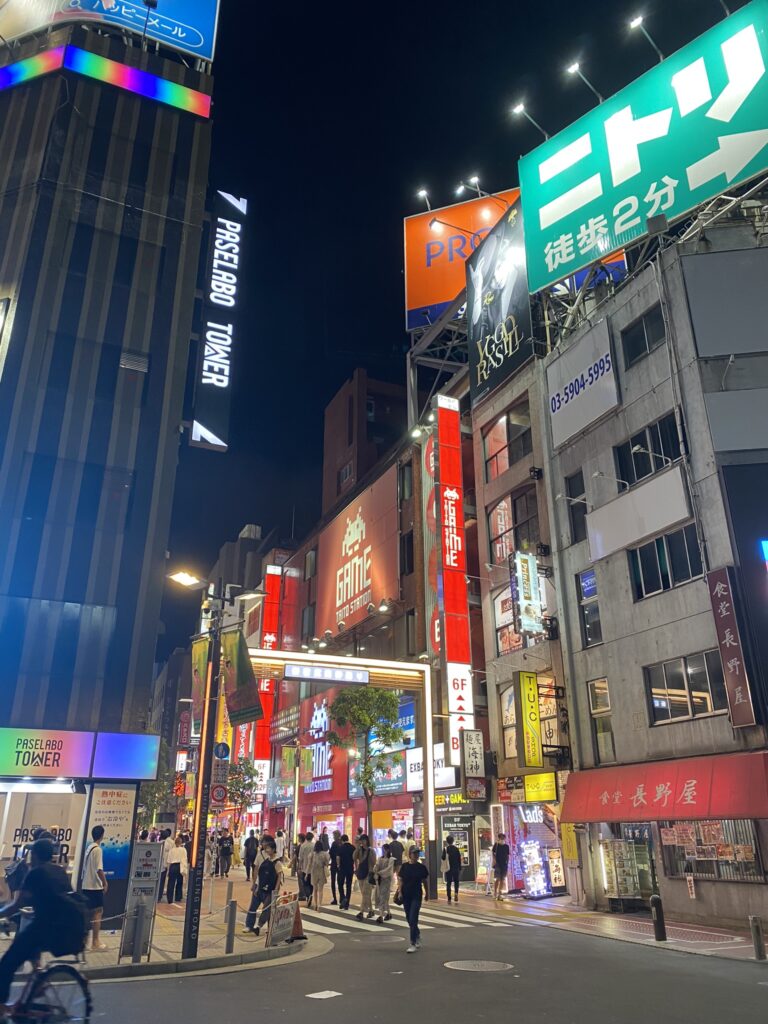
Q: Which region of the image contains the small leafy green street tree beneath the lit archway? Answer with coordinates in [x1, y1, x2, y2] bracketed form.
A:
[328, 686, 402, 825]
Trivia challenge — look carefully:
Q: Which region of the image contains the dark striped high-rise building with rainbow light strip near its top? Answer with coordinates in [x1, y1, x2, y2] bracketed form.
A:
[0, 26, 212, 730]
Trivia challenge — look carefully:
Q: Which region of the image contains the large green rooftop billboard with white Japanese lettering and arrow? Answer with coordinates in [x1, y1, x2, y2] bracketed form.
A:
[519, 0, 768, 293]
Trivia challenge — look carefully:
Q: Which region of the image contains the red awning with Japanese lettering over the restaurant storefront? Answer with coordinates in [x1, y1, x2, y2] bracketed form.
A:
[561, 751, 768, 822]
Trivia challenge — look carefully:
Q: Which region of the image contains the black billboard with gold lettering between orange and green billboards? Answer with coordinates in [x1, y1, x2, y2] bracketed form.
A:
[467, 197, 534, 406]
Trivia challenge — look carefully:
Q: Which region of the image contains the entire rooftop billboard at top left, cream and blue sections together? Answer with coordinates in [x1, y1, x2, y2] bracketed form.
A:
[0, 0, 219, 60]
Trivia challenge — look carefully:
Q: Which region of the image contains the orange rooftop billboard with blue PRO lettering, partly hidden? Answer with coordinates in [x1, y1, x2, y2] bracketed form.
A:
[404, 188, 520, 331]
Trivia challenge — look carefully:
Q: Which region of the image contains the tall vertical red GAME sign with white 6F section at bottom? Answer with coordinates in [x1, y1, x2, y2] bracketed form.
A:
[435, 395, 475, 765]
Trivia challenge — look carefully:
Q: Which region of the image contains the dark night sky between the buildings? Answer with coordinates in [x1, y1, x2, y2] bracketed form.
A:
[160, 0, 743, 655]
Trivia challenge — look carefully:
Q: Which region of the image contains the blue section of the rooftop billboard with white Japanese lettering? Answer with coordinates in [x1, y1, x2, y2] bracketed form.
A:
[54, 0, 219, 60]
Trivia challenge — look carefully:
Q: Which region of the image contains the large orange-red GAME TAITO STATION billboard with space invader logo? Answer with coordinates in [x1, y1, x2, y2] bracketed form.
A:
[314, 466, 399, 636]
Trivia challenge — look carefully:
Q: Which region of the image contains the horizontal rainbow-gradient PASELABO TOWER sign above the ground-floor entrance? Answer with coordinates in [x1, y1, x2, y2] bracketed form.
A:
[0, 728, 160, 781]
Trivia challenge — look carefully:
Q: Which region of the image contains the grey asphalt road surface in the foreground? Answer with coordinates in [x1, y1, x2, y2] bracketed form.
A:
[93, 913, 768, 1024]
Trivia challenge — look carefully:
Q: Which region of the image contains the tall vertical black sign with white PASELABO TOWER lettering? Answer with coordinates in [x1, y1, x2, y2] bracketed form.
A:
[190, 191, 248, 452]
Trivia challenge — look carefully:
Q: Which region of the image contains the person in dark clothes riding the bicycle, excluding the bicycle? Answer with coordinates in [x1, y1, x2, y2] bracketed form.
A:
[0, 839, 85, 1020]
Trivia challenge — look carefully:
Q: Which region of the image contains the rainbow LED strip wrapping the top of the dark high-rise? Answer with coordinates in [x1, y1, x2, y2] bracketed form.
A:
[0, 46, 211, 118]
